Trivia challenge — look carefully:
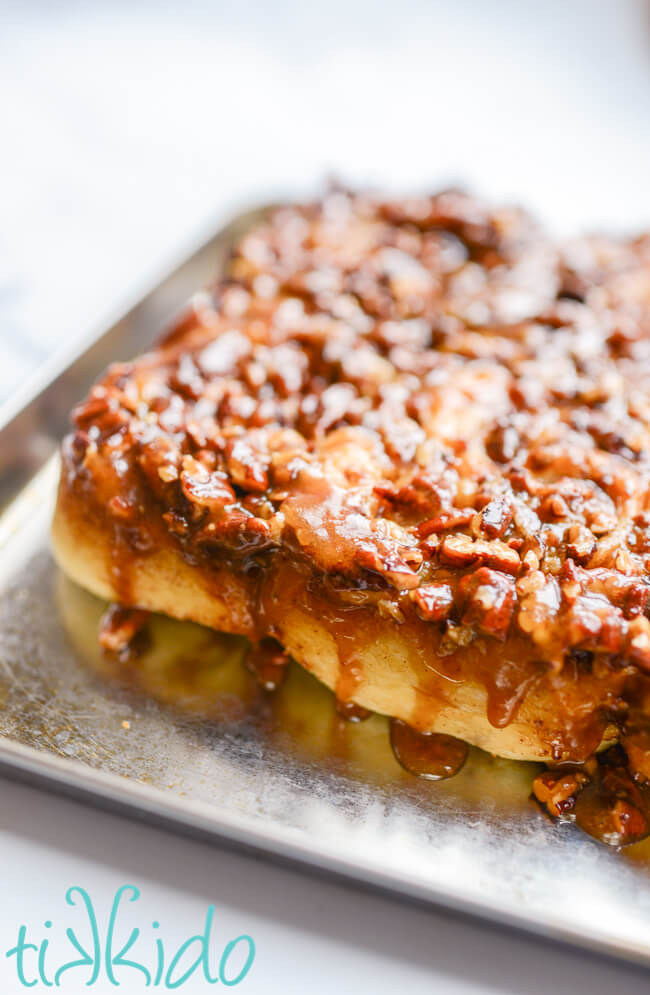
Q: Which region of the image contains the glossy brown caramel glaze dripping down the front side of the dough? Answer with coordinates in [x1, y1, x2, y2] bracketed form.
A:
[72, 408, 636, 784]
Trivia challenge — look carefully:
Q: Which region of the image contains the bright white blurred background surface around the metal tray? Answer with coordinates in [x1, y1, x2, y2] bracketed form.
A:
[0, 0, 650, 995]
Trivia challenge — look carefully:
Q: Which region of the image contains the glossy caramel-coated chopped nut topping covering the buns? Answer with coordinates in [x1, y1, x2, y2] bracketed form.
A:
[65, 190, 650, 673]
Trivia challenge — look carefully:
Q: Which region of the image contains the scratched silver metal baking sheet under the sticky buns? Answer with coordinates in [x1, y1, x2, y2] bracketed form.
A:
[0, 206, 650, 964]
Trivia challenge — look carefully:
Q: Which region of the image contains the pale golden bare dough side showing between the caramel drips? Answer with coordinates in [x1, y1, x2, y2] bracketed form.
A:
[52, 480, 616, 762]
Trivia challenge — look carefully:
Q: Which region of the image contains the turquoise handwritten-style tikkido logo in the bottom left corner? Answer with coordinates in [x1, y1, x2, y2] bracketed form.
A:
[5, 884, 255, 993]
